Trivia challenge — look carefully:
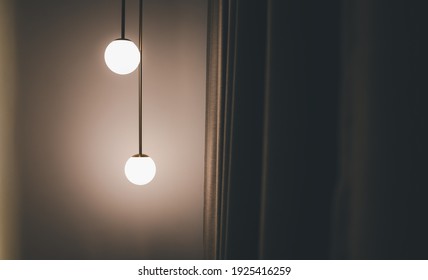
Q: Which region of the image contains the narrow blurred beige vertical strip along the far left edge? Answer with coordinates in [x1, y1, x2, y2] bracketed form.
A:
[0, 0, 19, 259]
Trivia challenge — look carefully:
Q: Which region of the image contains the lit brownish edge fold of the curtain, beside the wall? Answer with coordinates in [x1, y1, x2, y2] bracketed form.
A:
[204, 1, 225, 259]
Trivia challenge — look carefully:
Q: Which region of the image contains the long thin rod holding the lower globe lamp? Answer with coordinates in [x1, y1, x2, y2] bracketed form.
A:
[139, 0, 143, 156]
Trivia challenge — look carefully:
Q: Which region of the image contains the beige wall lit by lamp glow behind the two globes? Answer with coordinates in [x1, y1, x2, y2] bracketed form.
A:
[15, 0, 207, 259]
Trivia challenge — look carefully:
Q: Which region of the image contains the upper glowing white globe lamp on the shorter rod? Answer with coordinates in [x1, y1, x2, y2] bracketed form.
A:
[104, 39, 140, 75]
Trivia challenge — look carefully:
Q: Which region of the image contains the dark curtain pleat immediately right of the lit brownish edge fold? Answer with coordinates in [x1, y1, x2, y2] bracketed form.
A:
[224, 0, 266, 259]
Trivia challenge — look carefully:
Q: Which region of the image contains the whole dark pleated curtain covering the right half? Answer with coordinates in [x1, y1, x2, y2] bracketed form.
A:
[204, 0, 428, 259]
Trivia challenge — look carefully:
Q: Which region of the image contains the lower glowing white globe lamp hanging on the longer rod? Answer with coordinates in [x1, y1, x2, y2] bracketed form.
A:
[125, 154, 156, 185]
